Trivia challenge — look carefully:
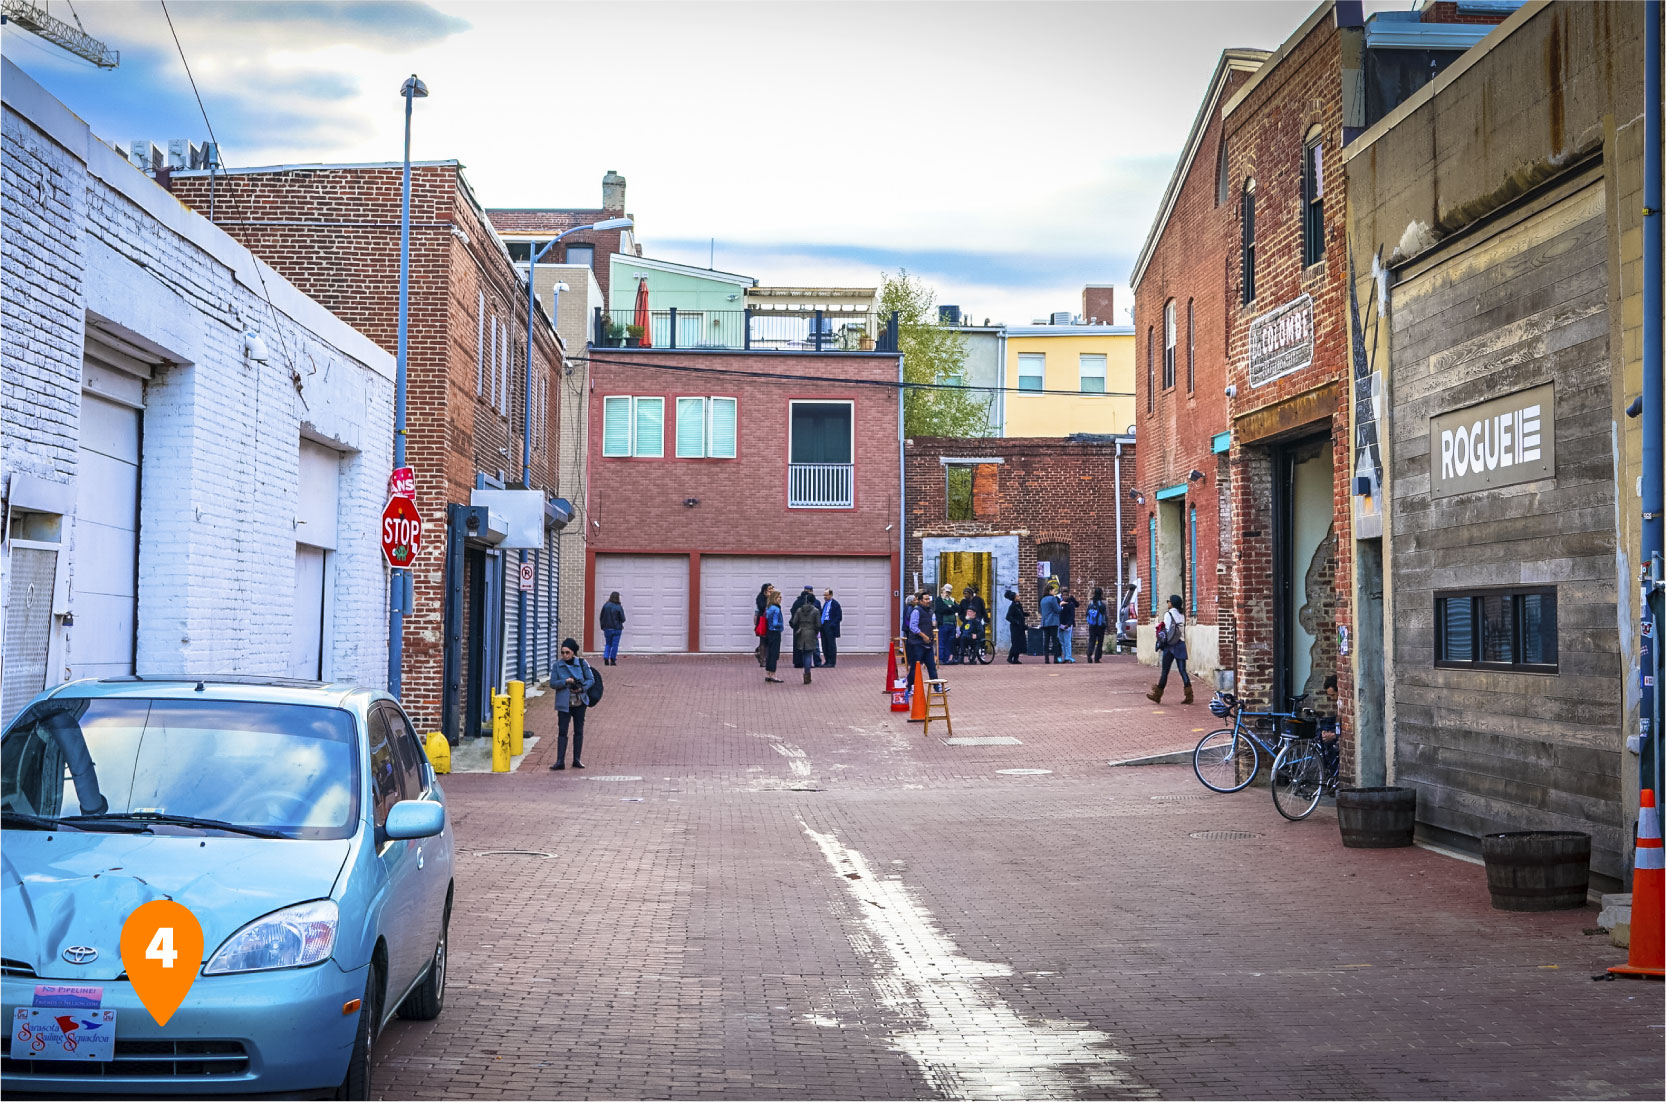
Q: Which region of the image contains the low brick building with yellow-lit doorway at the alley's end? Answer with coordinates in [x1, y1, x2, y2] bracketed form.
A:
[904, 435, 1139, 652]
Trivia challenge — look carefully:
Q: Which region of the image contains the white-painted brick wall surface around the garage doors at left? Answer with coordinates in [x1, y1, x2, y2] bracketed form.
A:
[0, 63, 394, 687]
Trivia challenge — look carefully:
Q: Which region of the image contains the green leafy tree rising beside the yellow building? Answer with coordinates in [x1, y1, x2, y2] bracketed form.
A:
[881, 269, 994, 437]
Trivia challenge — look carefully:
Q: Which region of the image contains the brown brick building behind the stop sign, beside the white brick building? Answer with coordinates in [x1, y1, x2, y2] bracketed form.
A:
[172, 162, 567, 739]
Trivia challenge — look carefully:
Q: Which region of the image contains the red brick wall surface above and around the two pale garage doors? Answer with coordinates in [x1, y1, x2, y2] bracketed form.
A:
[584, 347, 899, 650]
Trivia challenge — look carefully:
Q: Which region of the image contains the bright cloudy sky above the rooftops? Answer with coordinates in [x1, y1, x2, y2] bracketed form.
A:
[3, 0, 1374, 324]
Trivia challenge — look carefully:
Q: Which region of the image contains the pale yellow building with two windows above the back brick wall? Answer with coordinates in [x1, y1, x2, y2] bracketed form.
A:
[1002, 324, 1136, 435]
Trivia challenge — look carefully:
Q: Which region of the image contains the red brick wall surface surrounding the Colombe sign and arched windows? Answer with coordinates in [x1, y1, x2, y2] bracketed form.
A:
[1223, 10, 1354, 777]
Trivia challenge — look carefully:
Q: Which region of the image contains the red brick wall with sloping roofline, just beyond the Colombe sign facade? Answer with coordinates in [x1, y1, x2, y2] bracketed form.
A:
[1134, 70, 1251, 650]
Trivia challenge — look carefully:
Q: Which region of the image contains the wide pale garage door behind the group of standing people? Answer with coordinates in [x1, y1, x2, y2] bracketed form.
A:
[701, 556, 892, 652]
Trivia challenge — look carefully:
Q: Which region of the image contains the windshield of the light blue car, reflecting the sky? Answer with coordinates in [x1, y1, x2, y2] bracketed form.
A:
[0, 699, 359, 839]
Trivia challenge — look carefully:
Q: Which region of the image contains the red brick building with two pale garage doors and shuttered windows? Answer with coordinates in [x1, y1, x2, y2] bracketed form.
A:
[585, 347, 902, 652]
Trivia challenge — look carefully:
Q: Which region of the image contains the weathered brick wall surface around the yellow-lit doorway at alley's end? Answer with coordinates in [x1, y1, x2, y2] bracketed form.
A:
[904, 435, 1139, 617]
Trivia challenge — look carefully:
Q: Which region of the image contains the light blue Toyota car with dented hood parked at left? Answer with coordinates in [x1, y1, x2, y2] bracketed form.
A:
[0, 677, 452, 1099]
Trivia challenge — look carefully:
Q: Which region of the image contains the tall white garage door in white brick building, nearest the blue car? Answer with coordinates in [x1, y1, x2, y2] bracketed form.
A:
[68, 394, 138, 679]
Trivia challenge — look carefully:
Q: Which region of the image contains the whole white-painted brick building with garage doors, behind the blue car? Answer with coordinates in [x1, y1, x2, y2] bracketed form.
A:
[0, 60, 394, 719]
